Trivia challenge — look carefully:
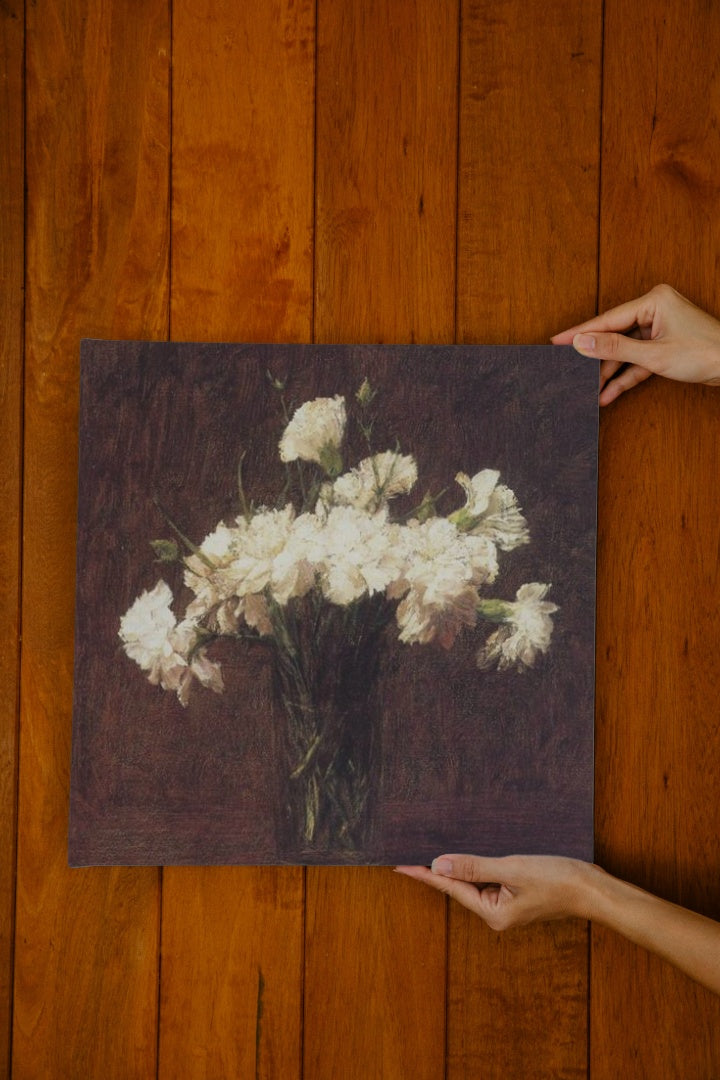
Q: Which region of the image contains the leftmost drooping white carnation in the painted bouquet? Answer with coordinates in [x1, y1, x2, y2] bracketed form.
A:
[119, 580, 222, 705]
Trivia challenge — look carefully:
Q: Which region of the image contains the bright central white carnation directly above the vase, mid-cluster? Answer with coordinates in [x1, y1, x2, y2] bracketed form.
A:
[316, 507, 403, 607]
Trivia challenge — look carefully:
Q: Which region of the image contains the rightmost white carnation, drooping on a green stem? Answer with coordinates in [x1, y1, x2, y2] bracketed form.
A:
[477, 581, 557, 671]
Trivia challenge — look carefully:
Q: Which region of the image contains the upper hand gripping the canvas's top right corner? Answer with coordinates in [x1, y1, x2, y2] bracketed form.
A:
[551, 285, 720, 405]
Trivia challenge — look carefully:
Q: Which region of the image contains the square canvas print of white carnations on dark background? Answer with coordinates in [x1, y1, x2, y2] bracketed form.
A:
[70, 341, 597, 865]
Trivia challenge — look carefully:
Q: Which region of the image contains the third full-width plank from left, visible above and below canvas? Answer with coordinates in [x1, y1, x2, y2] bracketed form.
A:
[304, 0, 458, 1080]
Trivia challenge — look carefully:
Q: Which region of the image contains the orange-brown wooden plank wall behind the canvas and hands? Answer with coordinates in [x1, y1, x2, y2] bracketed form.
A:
[0, 0, 720, 1080]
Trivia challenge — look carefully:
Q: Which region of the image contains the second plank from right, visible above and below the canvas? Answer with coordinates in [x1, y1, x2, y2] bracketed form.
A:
[451, 0, 601, 1078]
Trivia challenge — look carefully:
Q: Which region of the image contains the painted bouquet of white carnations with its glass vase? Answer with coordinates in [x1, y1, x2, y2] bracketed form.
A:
[118, 373, 562, 856]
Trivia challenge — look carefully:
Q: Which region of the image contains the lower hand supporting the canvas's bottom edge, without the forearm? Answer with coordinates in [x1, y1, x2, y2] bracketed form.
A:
[396, 855, 604, 930]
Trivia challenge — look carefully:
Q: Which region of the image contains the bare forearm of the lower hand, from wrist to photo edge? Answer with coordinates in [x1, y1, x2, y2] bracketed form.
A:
[579, 867, 720, 994]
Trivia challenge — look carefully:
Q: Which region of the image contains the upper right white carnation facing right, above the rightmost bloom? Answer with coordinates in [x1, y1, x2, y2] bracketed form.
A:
[450, 469, 530, 551]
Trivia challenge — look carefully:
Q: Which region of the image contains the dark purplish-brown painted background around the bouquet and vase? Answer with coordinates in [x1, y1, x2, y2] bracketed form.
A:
[70, 341, 597, 865]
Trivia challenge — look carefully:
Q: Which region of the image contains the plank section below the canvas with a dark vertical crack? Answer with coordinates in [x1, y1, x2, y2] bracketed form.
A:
[160, 867, 302, 1080]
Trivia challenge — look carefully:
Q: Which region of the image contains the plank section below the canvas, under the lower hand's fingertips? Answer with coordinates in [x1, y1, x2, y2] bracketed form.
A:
[303, 867, 446, 1080]
